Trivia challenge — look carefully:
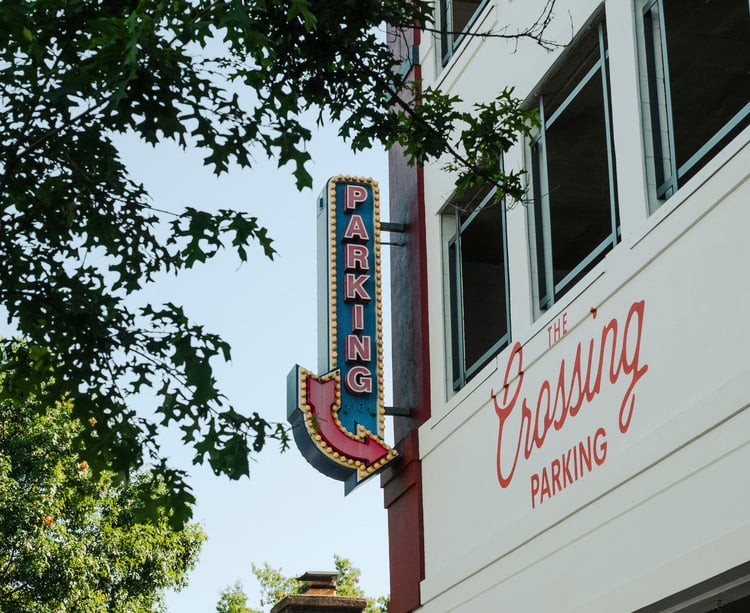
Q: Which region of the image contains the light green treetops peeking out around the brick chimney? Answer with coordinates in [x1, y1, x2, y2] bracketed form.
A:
[216, 555, 389, 613]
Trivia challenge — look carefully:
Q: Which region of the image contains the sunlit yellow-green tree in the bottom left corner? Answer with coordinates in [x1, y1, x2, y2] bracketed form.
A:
[0, 384, 204, 613]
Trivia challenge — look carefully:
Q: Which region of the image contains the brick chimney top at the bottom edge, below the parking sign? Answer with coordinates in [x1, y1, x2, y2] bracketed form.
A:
[271, 571, 367, 613]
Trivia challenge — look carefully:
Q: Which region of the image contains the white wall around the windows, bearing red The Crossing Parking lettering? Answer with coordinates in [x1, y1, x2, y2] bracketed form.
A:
[406, 0, 750, 611]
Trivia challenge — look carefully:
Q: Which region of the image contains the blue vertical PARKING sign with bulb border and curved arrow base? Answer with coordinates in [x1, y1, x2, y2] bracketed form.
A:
[287, 175, 398, 492]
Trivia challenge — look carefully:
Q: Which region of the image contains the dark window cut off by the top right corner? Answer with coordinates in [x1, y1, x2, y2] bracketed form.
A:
[643, 0, 750, 201]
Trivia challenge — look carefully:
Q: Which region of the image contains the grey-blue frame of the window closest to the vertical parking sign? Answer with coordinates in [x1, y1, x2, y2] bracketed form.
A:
[443, 187, 512, 393]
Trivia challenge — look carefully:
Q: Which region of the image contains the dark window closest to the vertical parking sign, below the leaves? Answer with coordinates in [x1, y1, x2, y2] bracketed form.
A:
[444, 184, 510, 390]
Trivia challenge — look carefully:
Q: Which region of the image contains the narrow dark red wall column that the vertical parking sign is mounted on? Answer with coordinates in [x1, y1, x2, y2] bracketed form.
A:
[381, 22, 430, 612]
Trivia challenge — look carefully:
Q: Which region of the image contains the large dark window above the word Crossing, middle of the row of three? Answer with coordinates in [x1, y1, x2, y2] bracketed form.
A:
[527, 23, 619, 310]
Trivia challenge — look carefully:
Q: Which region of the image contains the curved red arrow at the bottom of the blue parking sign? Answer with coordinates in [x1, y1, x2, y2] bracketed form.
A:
[307, 376, 389, 466]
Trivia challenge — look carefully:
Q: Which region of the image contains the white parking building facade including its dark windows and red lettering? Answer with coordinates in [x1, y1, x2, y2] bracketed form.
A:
[383, 0, 750, 612]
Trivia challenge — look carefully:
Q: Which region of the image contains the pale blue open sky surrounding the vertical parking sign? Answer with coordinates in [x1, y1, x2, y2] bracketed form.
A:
[123, 122, 391, 613]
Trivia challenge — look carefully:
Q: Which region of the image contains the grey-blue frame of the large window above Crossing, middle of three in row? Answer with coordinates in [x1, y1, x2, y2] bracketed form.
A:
[526, 19, 621, 317]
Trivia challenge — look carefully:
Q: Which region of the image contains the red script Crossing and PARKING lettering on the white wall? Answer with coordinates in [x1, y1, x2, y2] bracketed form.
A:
[491, 300, 648, 508]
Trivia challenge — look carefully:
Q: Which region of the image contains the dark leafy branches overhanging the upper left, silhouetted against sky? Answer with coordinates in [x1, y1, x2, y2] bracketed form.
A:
[0, 0, 560, 526]
